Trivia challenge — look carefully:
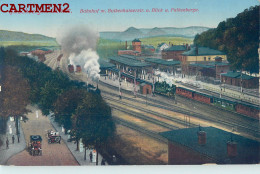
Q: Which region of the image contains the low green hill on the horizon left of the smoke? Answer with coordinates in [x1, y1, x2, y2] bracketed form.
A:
[0, 30, 56, 42]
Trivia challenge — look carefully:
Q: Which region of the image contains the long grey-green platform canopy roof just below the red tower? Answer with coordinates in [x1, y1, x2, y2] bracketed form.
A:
[109, 56, 151, 67]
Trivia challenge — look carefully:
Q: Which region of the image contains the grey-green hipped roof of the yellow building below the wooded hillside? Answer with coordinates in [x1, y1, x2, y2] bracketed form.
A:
[182, 47, 225, 56]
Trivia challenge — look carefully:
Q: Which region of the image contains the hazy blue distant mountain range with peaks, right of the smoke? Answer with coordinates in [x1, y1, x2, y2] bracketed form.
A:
[100, 26, 210, 41]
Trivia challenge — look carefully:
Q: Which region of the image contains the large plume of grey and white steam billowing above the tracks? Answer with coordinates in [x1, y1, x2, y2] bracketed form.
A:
[57, 25, 100, 80]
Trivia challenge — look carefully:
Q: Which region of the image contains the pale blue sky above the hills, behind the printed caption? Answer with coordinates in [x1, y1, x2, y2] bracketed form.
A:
[0, 0, 259, 37]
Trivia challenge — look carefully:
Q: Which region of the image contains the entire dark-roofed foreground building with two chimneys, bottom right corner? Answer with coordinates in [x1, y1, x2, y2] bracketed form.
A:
[160, 127, 260, 165]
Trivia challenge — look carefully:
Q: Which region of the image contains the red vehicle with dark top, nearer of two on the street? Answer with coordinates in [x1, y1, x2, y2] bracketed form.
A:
[28, 135, 42, 156]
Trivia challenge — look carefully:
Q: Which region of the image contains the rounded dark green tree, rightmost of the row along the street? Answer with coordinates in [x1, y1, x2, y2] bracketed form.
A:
[74, 93, 115, 165]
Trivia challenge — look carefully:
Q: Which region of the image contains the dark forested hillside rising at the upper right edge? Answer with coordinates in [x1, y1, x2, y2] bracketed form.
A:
[194, 6, 259, 73]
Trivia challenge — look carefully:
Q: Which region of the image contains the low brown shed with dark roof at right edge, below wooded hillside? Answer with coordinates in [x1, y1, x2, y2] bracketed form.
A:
[221, 71, 259, 89]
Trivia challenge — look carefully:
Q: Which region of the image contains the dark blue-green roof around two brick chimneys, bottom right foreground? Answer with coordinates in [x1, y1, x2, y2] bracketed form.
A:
[160, 127, 259, 164]
